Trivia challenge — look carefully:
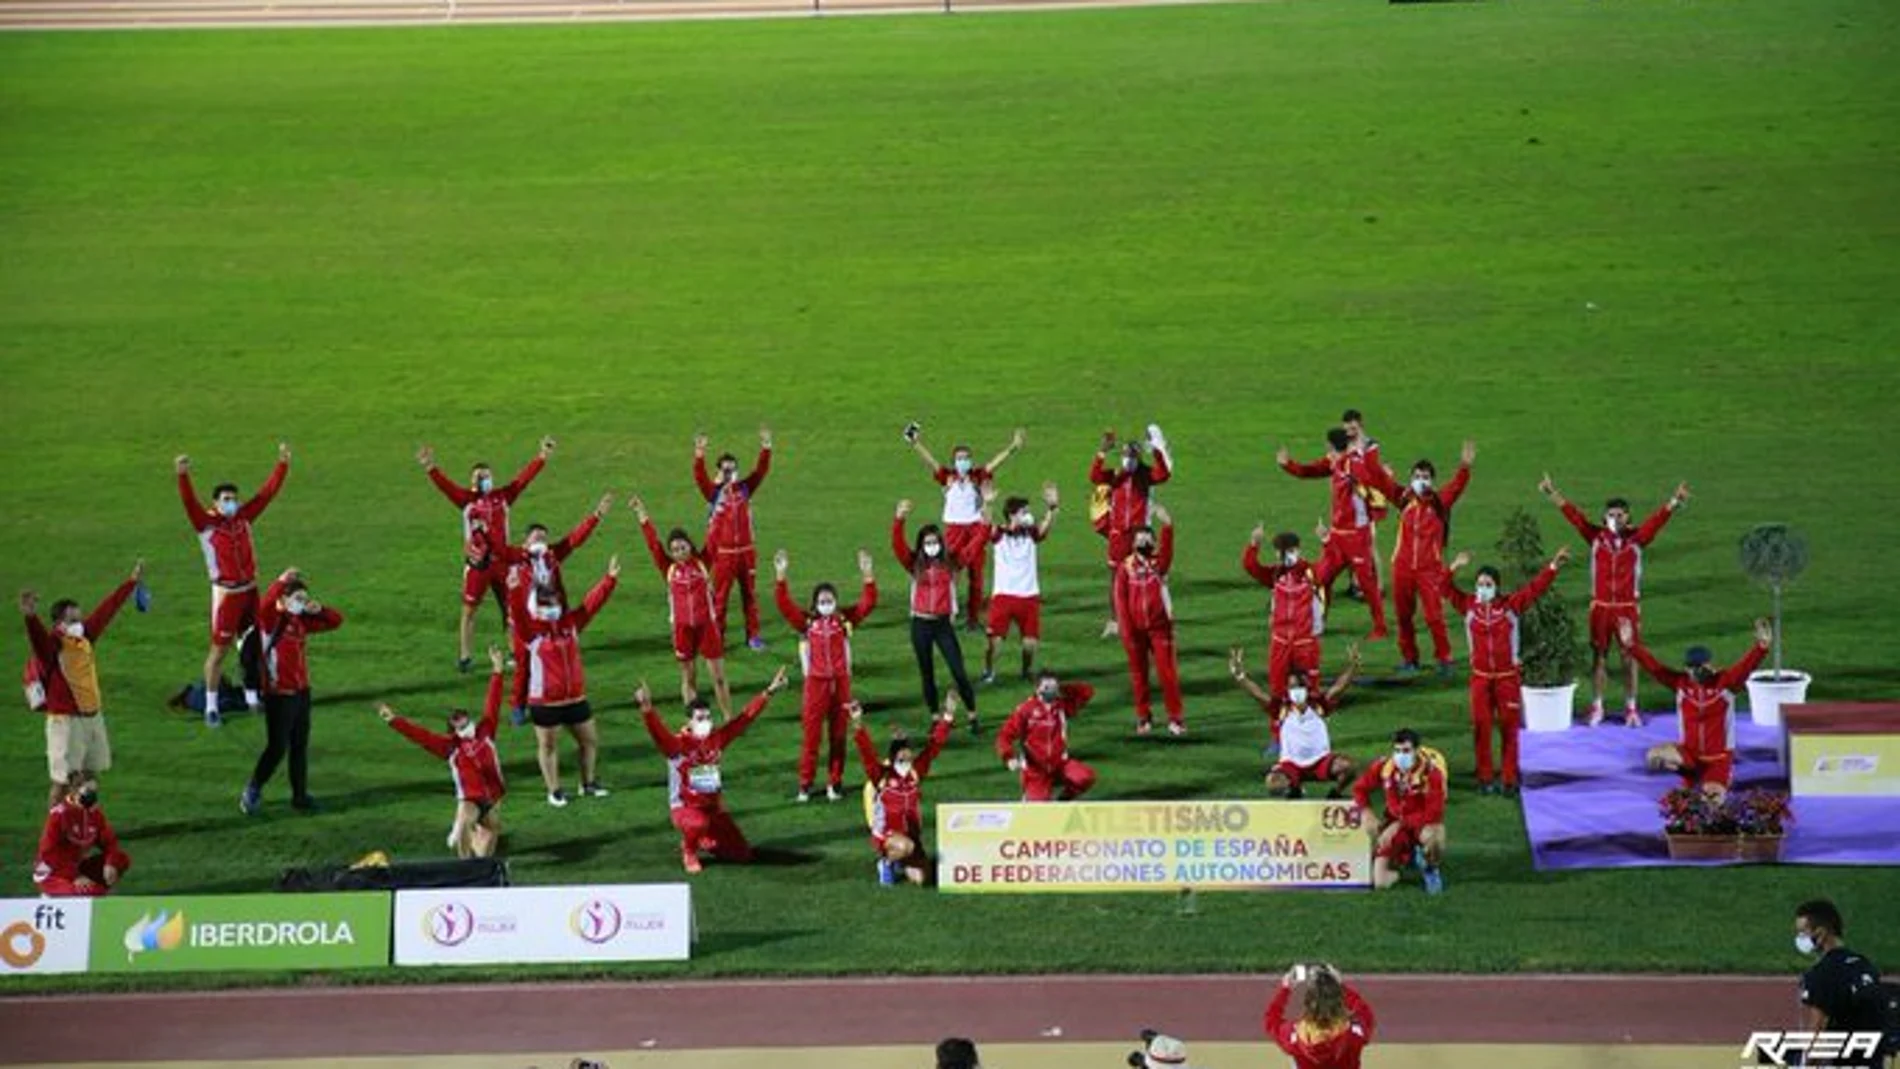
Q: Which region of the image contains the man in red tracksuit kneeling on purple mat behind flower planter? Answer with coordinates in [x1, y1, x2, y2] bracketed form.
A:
[1617, 619, 1775, 794]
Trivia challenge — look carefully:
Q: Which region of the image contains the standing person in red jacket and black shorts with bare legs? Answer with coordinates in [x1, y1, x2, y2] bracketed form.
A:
[517, 556, 619, 809]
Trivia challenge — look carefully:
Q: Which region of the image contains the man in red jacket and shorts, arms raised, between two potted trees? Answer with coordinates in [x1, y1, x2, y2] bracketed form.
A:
[1537, 475, 1689, 727]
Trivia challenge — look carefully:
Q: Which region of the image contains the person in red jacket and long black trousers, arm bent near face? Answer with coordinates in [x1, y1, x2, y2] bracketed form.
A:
[238, 568, 344, 813]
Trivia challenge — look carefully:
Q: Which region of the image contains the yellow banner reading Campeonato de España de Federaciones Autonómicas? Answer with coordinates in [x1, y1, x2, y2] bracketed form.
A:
[937, 801, 1372, 894]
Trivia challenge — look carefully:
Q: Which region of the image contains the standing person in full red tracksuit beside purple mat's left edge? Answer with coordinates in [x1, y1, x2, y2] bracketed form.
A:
[1444, 549, 1569, 796]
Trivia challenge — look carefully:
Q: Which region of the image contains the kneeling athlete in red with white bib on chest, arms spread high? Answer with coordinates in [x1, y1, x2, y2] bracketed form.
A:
[633, 668, 785, 872]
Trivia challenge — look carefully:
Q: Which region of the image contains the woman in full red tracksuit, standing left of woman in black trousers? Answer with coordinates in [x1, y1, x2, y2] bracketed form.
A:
[771, 549, 878, 801]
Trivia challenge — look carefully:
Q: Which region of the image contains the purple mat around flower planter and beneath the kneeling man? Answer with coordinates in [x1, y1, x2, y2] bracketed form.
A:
[1518, 712, 1900, 870]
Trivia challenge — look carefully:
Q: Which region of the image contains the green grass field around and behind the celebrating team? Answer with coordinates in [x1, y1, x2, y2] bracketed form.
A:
[0, 0, 1900, 984]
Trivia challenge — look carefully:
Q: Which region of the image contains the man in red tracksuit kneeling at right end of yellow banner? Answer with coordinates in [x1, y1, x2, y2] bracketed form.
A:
[1353, 727, 1444, 894]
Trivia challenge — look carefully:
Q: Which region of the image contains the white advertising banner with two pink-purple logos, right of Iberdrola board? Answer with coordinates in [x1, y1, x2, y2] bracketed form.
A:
[395, 883, 694, 965]
